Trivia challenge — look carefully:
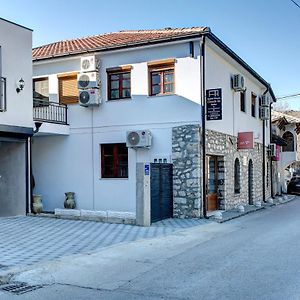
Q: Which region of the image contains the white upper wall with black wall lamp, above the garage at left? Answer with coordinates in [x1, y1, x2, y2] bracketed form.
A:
[0, 19, 33, 127]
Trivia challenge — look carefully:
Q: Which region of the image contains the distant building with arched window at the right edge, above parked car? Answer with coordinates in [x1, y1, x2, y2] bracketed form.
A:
[272, 111, 300, 194]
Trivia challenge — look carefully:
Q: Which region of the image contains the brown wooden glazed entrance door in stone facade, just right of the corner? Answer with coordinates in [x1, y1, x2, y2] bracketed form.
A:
[206, 155, 218, 211]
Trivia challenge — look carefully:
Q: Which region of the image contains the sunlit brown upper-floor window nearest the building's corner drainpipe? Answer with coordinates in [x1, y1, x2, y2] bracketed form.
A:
[148, 59, 175, 96]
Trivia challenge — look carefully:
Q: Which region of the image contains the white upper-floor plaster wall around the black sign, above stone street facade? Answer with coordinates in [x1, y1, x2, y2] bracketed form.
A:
[206, 42, 270, 144]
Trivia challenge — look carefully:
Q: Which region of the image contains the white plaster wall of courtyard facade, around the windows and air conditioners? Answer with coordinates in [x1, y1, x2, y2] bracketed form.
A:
[33, 43, 201, 212]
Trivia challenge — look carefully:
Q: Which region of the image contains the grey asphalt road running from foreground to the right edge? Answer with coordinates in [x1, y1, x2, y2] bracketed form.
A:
[0, 198, 300, 300]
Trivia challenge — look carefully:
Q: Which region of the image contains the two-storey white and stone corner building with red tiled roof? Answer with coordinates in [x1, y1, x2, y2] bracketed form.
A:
[33, 27, 275, 223]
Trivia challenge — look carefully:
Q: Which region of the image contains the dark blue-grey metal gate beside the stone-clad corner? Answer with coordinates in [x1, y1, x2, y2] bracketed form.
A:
[150, 163, 173, 222]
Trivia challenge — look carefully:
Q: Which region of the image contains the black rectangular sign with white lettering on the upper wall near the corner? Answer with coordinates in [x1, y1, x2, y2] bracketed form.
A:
[206, 89, 222, 121]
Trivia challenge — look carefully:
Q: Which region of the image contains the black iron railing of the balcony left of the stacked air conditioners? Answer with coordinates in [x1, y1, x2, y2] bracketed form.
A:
[33, 99, 68, 125]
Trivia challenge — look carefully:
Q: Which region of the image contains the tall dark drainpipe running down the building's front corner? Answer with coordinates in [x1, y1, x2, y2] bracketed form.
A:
[200, 36, 208, 219]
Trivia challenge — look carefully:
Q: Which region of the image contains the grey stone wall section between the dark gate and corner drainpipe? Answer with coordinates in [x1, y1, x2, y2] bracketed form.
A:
[172, 125, 202, 218]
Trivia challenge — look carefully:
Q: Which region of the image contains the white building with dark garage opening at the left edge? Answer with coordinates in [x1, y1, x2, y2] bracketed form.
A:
[0, 18, 33, 216]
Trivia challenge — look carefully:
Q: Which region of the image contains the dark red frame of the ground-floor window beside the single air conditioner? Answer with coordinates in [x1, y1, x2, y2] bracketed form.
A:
[100, 143, 129, 179]
